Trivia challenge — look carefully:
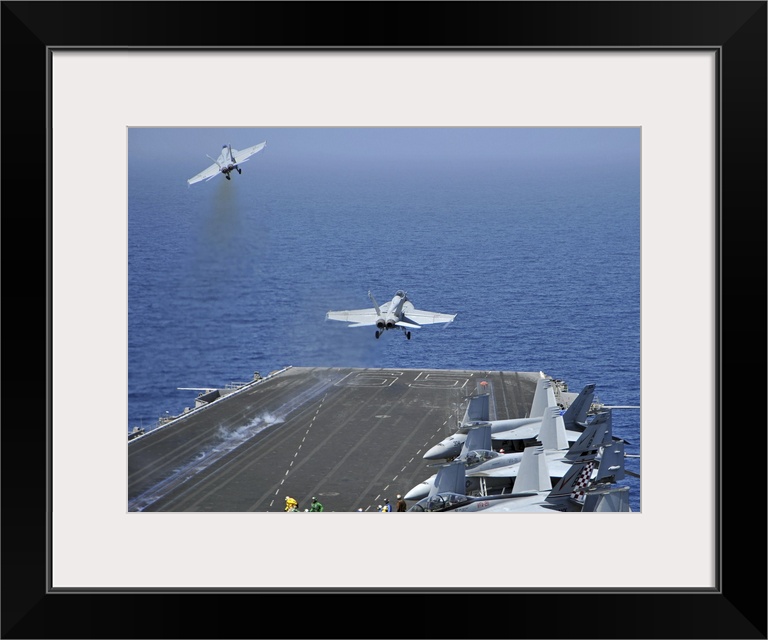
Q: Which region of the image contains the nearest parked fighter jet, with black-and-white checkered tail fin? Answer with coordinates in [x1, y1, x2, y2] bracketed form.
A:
[408, 443, 630, 513]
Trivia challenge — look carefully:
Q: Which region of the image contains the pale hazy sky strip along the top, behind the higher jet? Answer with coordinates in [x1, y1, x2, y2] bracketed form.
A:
[128, 127, 640, 176]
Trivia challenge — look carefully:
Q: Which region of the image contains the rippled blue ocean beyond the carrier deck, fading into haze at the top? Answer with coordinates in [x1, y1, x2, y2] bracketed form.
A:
[127, 128, 641, 511]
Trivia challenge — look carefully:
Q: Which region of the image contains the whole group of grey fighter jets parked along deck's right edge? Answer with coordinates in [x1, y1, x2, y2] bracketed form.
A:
[403, 375, 637, 512]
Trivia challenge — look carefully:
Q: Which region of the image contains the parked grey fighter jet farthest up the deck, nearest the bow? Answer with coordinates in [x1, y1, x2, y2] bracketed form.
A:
[423, 378, 595, 460]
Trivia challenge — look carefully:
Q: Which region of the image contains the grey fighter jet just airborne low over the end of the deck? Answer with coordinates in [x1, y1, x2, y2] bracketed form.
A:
[325, 290, 456, 340]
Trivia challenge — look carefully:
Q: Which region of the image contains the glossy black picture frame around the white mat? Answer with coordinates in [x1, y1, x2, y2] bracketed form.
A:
[1, 1, 767, 638]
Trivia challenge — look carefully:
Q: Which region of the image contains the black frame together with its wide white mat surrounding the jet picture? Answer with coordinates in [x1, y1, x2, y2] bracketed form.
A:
[2, 2, 766, 638]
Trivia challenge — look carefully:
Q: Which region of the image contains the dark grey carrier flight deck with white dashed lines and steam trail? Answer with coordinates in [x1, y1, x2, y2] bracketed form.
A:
[128, 367, 576, 512]
